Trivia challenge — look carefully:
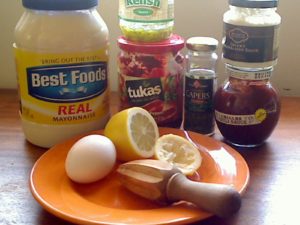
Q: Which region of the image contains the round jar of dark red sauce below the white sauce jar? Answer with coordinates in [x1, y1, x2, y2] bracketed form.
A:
[214, 65, 280, 147]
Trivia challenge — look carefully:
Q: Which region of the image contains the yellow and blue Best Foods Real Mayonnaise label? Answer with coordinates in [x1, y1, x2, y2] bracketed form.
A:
[14, 48, 109, 125]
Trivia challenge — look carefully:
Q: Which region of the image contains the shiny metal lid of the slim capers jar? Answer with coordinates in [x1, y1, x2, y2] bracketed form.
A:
[186, 37, 219, 52]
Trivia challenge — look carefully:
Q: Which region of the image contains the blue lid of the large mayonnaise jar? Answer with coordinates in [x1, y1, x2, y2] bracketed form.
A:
[22, 0, 98, 11]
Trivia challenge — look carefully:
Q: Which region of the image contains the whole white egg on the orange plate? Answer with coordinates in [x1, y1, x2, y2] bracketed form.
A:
[65, 135, 116, 183]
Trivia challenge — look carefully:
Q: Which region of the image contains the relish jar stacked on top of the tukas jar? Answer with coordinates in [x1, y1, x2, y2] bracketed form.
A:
[119, 0, 174, 42]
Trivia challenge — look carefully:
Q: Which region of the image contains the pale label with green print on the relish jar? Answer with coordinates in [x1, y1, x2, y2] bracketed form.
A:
[119, 0, 174, 23]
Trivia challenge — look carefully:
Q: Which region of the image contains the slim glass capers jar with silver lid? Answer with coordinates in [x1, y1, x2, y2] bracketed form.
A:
[183, 37, 218, 135]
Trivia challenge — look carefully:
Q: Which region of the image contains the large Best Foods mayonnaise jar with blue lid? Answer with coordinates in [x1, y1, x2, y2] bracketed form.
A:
[13, 0, 109, 147]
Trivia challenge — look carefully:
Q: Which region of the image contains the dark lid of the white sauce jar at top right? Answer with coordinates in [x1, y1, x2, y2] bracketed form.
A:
[229, 0, 278, 8]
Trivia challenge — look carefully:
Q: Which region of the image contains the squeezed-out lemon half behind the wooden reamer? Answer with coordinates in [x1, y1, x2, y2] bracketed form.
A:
[154, 134, 202, 175]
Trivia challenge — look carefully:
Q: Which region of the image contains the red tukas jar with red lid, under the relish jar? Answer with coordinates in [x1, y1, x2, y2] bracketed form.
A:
[118, 35, 184, 127]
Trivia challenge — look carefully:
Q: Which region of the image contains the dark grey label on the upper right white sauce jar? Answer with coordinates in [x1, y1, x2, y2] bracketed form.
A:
[223, 23, 279, 63]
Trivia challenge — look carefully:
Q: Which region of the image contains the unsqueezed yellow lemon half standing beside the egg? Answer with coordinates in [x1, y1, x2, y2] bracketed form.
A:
[104, 107, 159, 161]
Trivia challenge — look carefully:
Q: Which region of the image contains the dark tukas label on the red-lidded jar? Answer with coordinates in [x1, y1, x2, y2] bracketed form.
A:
[119, 74, 182, 125]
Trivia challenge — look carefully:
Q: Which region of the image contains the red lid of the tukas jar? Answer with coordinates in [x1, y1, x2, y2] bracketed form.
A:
[118, 34, 184, 54]
